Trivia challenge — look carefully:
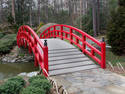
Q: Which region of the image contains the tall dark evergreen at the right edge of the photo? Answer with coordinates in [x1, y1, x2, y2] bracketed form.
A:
[107, 0, 125, 55]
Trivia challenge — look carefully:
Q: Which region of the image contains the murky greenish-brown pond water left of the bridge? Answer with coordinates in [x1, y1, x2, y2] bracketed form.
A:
[0, 62, 38, 80]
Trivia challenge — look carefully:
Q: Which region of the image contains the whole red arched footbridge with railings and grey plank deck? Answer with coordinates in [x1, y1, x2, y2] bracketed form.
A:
[17, 24, 106, 77]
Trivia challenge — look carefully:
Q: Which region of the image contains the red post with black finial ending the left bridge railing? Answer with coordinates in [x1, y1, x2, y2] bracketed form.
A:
[43, 40, 49, 77]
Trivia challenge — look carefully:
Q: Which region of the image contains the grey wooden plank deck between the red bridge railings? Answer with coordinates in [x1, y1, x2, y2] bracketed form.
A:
[41, 39, 99, 75]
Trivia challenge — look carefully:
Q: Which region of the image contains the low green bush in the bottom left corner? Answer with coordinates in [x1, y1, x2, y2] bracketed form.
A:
[0, 77, 25, 94]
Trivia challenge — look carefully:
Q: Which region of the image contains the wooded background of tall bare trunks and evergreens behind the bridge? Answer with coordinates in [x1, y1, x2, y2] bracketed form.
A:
[0, 0, 118, 36]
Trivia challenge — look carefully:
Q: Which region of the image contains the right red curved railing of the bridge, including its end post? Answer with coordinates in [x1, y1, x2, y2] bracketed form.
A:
[40, 24, 106, 69]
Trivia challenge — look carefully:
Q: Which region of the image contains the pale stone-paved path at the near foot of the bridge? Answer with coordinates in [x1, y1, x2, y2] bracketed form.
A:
[52, 68, 125, 94]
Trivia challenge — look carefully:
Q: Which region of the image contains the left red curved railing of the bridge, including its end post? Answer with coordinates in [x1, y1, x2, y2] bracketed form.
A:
[17, 25, 48, 77]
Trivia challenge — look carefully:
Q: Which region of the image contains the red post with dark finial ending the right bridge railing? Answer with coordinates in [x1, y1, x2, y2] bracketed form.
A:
[101, 37, 106, 69]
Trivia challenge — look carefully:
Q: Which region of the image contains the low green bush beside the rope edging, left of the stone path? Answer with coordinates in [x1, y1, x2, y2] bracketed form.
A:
[21, 75, 51, 94]
